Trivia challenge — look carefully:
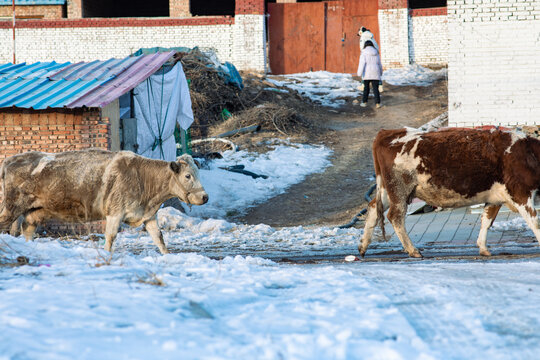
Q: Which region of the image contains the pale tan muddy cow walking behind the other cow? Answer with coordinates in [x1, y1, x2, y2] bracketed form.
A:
[0, 149, 208, 254]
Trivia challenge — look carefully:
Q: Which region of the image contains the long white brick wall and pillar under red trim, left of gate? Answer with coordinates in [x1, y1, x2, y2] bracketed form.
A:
[0, 15, 266, 72]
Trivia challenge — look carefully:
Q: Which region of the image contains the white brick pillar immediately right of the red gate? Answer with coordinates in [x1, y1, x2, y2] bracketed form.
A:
[379, 8, 409, 68]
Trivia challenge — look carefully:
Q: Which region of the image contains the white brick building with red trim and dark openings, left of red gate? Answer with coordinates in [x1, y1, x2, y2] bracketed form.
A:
[0, 0, 266, 72]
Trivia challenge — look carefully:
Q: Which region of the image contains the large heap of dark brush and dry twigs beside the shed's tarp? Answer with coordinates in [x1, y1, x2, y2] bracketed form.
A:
[175, 48, 309, 139]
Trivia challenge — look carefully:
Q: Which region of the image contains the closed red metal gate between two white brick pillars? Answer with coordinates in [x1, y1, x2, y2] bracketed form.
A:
[268, 0, 379, 74]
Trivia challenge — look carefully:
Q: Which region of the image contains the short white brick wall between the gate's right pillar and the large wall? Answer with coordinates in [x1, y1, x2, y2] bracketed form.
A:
[409, 15, 448, 66]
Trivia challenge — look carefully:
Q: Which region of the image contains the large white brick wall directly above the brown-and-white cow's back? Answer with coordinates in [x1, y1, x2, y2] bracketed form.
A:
[448, 0, 540, 126]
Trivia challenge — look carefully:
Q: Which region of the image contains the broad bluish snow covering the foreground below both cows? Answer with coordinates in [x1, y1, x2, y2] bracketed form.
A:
[0, 233, 540, 360]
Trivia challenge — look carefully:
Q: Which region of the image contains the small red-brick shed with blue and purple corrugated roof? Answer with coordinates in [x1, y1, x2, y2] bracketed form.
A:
[0, 51, 174, 164]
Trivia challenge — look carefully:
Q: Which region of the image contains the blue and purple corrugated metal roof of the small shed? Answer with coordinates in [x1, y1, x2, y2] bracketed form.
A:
[0, 51, 174, 110]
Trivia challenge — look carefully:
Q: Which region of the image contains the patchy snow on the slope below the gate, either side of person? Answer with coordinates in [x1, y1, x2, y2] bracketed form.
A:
[267, 64, 448, 108]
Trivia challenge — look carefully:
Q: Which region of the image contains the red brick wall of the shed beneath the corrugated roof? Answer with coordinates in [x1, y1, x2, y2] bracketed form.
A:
[0, 109, 110, 163]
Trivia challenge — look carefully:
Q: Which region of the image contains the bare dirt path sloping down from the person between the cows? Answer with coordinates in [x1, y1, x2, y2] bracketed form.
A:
[234, 80, 448, 227]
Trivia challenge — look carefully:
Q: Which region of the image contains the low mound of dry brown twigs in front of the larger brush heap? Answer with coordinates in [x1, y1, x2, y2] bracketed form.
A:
[210, 102, 311, 136]
